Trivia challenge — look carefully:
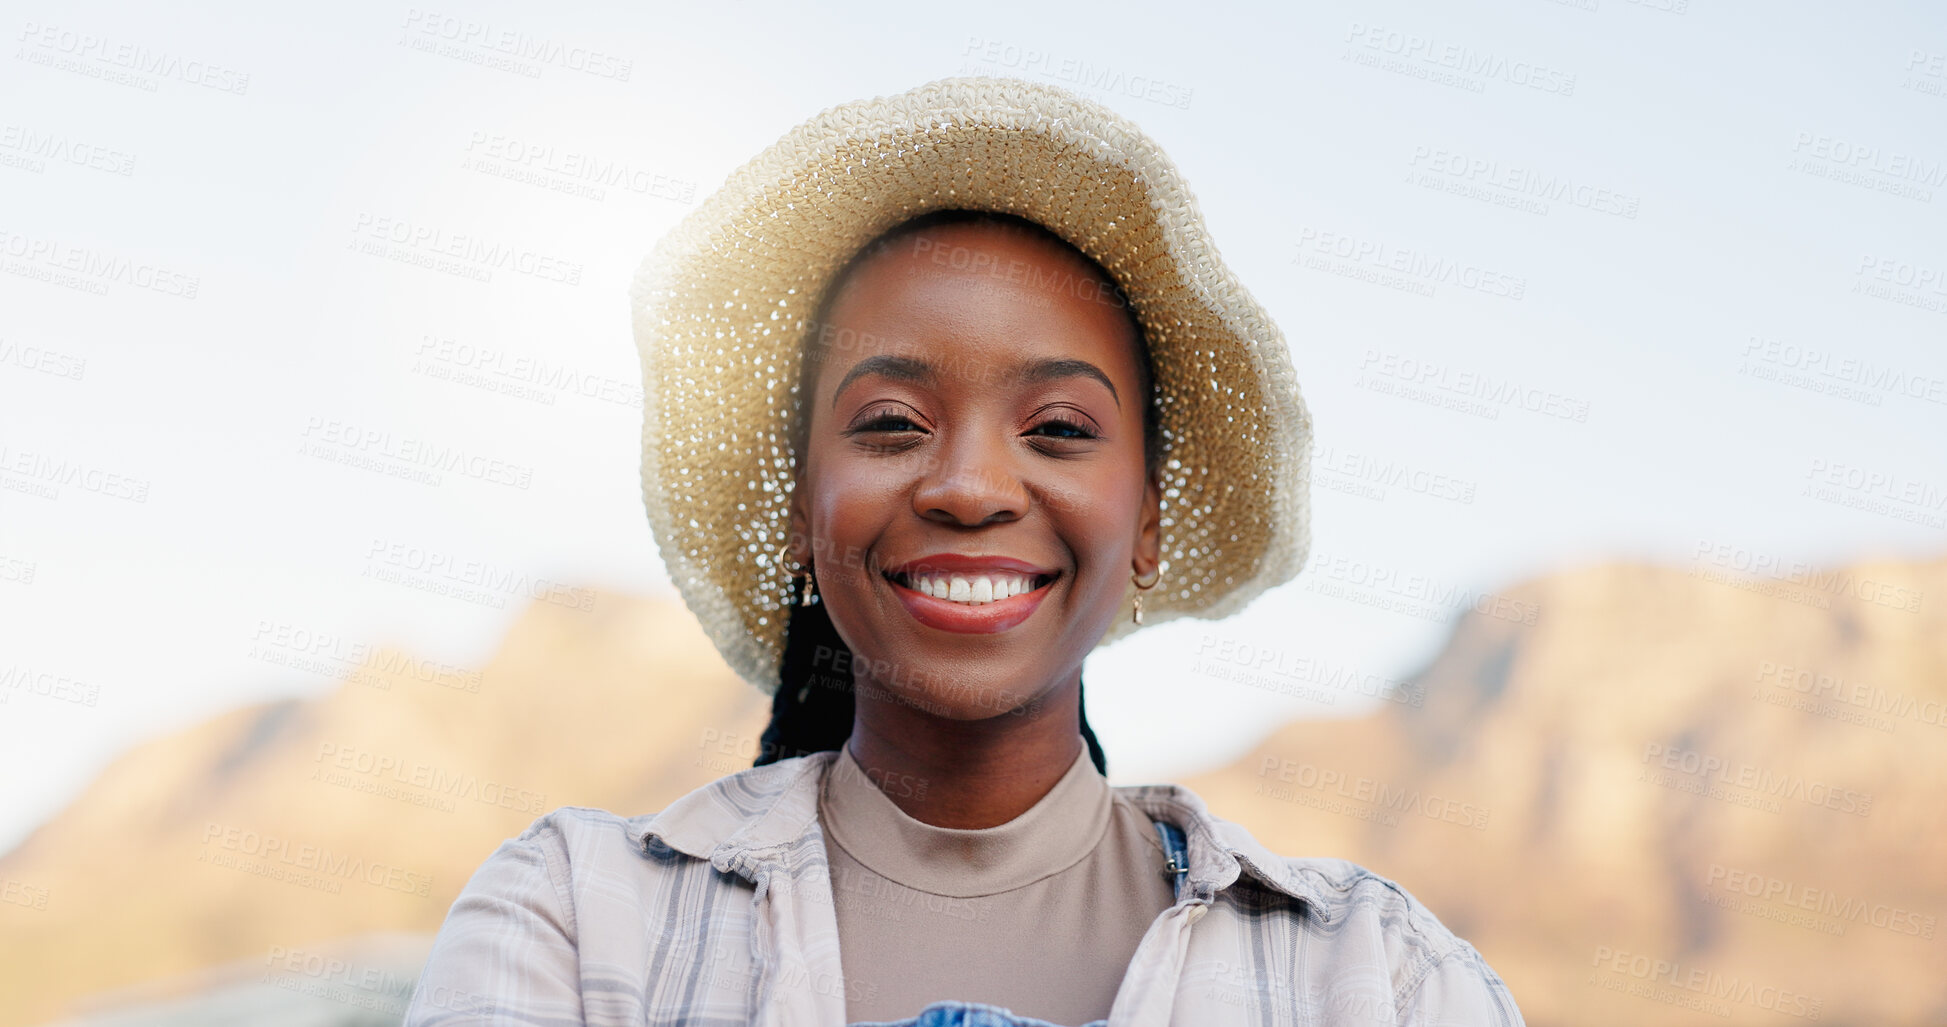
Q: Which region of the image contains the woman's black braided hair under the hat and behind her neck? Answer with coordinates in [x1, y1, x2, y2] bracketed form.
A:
[752, 209, 1162, 776]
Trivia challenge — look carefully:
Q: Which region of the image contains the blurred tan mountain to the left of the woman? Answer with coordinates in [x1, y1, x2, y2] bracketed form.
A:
[0, 589, 769, 1025]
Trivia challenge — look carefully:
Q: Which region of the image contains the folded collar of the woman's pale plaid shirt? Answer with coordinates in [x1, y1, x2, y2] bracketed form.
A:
[629, 750, 1326, 910]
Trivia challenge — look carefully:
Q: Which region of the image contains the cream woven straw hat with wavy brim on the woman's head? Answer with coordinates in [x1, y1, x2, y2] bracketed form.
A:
[631, 78, 1312, 694]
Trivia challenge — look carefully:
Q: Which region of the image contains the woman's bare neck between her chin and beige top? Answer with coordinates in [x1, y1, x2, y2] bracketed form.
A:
[845, 674, 1084, 828]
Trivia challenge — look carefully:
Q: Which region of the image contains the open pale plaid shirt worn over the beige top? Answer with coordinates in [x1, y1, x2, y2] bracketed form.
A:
[405, 752, 1523, 1027]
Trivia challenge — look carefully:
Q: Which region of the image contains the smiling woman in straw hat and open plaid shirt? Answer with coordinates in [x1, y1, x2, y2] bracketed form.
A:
[407, 80, 1521, 1027]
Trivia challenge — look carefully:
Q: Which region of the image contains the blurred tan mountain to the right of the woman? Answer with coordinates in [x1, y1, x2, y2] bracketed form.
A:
[1184, 561, 1947, 1025]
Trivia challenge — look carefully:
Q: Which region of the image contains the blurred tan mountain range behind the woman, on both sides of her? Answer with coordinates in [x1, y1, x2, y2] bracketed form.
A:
[0, 561, 1947, 1027]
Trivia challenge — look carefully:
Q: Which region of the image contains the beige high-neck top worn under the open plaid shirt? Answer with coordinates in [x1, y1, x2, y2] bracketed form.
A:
[818, 746, 1176, 1027]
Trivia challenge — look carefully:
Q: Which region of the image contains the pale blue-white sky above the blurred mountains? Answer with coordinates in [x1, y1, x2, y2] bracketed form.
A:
[0, 0, 1947, 850]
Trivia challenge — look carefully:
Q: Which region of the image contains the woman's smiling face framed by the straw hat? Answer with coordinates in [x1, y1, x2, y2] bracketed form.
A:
[790, 222, 1160, 721]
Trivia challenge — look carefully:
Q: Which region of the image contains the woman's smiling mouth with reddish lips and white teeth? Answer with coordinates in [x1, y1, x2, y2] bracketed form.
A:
[884, 553, 1061, 633]
